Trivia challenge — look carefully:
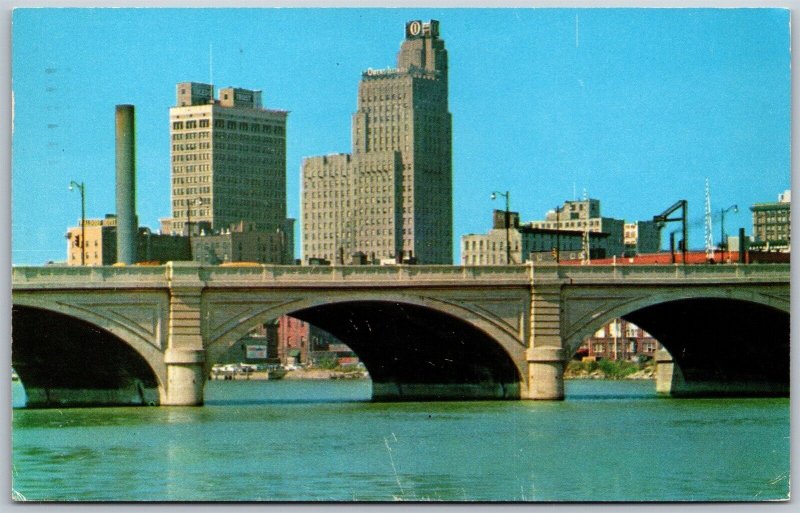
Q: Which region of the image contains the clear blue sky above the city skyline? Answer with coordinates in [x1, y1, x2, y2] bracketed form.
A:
[12, 8, 790, 264]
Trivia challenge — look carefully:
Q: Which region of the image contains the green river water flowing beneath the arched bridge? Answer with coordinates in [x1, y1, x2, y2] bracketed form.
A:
[11, 380, 790, 501]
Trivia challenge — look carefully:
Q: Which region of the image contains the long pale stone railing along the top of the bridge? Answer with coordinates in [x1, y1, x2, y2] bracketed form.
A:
[12, 262, 791, 289]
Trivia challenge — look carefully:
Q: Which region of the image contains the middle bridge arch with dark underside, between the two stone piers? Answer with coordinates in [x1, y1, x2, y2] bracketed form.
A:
[206, 291, 527, 399]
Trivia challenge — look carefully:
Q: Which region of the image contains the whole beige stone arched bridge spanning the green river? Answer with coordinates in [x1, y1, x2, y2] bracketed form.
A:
[12, 262, 790, 407]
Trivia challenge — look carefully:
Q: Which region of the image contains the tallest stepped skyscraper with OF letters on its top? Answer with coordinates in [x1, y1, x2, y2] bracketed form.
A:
[302, 20, 453, 264]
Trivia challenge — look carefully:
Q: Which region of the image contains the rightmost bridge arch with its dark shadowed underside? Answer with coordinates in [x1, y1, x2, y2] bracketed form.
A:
[564, 287, 790, 396]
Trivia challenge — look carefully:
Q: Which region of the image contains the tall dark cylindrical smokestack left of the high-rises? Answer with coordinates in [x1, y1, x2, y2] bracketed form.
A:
[116, 105, 138, 264]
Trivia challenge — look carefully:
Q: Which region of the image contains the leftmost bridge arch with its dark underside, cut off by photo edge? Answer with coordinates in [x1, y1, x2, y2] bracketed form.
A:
[12, 297, 166, 407]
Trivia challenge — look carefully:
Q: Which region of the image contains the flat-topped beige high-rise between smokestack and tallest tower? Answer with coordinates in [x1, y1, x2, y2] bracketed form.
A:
[168, 82, 291, 234]
